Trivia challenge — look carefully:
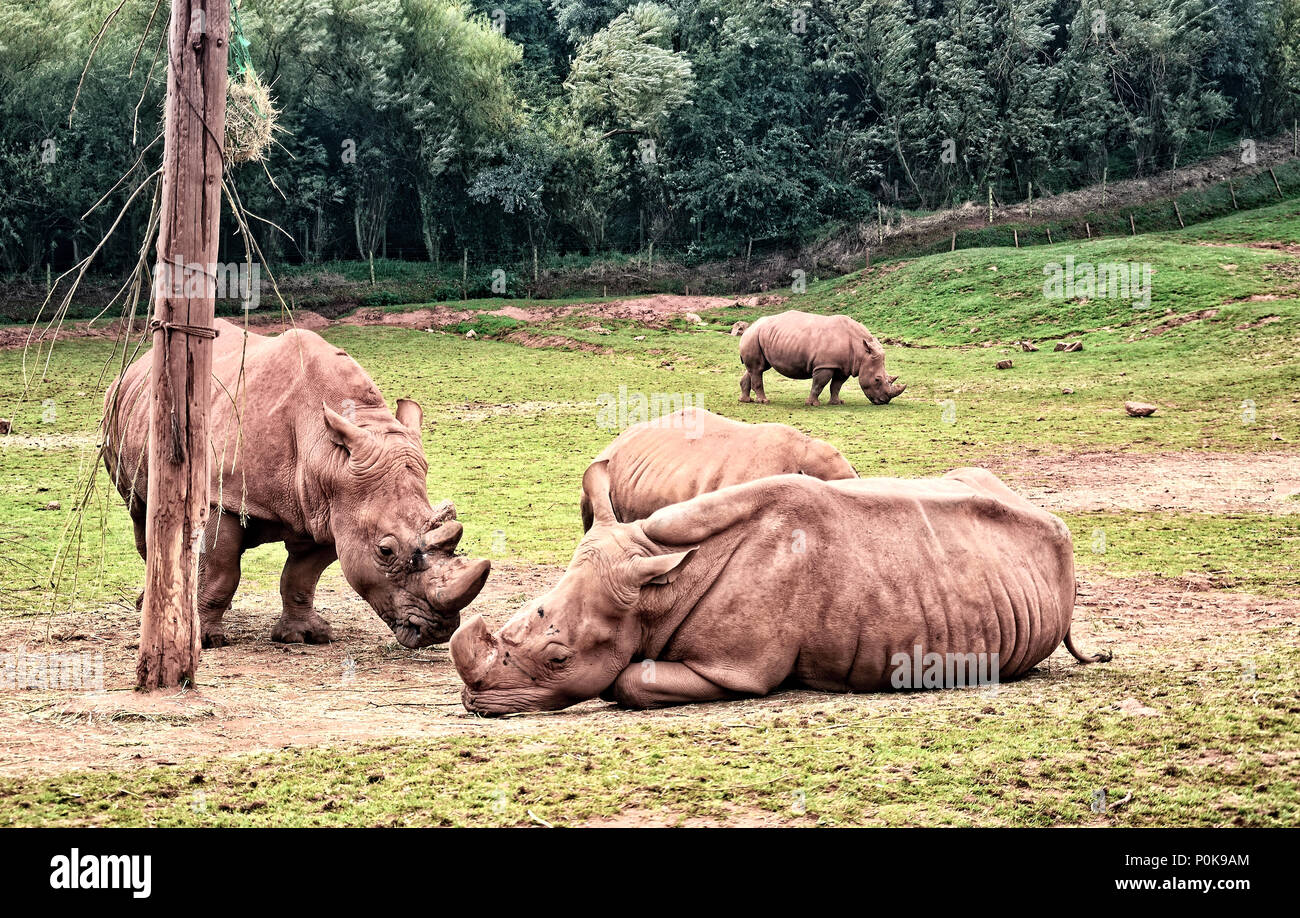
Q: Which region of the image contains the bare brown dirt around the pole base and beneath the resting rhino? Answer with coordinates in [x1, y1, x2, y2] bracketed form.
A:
[0, 553, 1300, 774]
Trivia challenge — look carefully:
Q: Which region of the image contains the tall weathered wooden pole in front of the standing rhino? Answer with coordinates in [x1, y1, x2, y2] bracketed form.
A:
[135, 0, 230, 690]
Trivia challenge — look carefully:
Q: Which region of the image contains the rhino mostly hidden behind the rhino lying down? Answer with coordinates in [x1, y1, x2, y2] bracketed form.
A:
[581, 408, 858, 532]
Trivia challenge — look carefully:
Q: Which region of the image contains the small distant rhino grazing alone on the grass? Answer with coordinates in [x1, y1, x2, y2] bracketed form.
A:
[740, 309, 907, 406]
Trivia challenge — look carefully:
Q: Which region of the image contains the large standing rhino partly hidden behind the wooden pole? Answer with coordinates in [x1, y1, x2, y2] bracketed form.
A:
[104, 320, 490, 648]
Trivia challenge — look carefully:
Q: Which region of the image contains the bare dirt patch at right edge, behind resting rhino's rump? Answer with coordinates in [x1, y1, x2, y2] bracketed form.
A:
[988, 451, 1300, 514]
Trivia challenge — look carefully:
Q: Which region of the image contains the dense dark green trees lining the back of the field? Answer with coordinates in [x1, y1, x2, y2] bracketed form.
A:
[0, 0, 1300, 272]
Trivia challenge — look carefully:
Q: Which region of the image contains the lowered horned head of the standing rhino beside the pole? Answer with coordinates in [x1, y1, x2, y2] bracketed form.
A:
[322, 399, 491, 648]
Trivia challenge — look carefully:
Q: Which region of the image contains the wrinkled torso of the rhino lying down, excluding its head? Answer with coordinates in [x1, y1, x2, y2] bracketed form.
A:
[647, 476, 1074, 692]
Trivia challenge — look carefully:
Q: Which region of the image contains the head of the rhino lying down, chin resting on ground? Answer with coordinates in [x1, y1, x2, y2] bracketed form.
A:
[451, 462, 694, 715]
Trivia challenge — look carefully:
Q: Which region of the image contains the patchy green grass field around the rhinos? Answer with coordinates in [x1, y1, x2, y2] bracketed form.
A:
[0, 192, 1300, 826]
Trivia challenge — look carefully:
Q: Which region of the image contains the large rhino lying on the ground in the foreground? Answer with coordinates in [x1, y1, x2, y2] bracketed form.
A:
[451, 463, 1109, 715]
